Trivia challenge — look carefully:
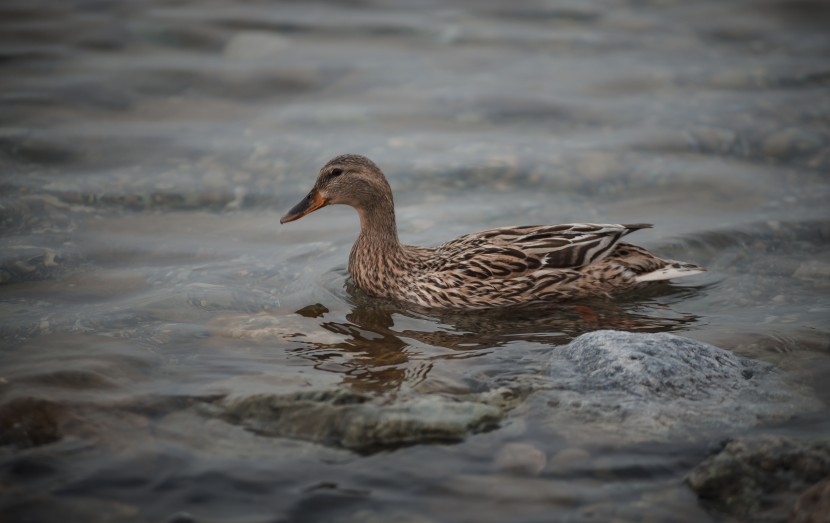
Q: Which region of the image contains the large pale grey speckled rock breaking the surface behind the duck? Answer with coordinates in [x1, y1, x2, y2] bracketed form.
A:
[547, 331, 820, 444]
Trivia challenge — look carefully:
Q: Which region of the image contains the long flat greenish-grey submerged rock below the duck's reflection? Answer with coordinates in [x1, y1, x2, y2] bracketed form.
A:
[222, 389, 501, 452]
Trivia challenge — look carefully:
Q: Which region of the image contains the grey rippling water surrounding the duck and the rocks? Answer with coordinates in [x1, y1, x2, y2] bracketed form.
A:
[0, 0, 830, 522]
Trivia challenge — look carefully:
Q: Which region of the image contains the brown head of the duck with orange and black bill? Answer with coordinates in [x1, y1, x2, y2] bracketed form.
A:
[280, 154, 392, 223]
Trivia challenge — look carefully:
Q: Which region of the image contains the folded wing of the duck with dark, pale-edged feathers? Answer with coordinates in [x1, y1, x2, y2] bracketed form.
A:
[435, 223, 651, 278]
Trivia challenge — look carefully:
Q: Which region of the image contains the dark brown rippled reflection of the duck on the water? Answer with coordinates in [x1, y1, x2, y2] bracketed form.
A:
[290, 283, 698, 392]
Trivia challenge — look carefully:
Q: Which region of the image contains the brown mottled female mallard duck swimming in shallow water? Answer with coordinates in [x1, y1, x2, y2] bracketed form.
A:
[280, 154, 705, 309]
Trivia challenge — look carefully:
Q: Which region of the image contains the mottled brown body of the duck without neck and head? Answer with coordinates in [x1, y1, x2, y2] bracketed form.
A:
[391, 223, 703, 308]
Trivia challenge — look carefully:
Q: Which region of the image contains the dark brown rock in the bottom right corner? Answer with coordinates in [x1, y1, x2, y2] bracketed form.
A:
[687, 436, 830, 522]
